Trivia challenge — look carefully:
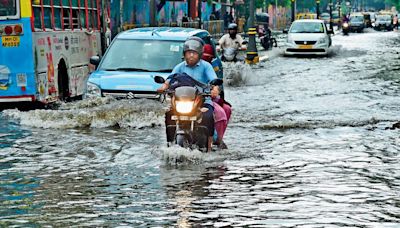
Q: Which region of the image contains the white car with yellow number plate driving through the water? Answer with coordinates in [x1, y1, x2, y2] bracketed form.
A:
[283, 19, 333, 55]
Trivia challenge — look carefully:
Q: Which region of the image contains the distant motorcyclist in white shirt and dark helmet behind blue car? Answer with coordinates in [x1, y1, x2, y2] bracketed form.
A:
[218, 23, 246, 61]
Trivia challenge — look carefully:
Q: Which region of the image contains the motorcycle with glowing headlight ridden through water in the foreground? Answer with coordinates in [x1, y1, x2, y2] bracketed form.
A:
[154, 74, 223, 151]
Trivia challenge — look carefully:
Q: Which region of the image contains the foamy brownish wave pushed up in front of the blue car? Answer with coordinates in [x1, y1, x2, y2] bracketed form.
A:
[3, 98, 165, 129]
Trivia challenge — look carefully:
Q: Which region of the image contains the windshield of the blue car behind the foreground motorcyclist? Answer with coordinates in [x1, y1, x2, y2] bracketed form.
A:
[99, 39, 183, 72]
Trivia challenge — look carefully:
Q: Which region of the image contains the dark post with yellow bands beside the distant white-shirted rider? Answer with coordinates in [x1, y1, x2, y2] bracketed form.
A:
[246, 0, 259, 64]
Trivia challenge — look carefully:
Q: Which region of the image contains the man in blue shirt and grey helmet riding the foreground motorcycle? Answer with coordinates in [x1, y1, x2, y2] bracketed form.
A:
[158, 37, 217, 151]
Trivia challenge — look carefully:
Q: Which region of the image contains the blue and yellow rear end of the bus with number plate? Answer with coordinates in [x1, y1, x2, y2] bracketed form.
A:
[0, 0, 36, 102]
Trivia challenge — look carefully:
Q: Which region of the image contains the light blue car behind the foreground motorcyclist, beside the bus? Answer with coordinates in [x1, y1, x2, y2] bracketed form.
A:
[87, 27, 222, 99]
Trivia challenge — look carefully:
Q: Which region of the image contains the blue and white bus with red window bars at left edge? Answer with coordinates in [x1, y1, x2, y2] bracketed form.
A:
[0, 0, 108, 105]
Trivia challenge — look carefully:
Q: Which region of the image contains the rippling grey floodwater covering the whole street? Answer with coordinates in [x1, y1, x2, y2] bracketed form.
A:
[0, 30, 400, 227]
